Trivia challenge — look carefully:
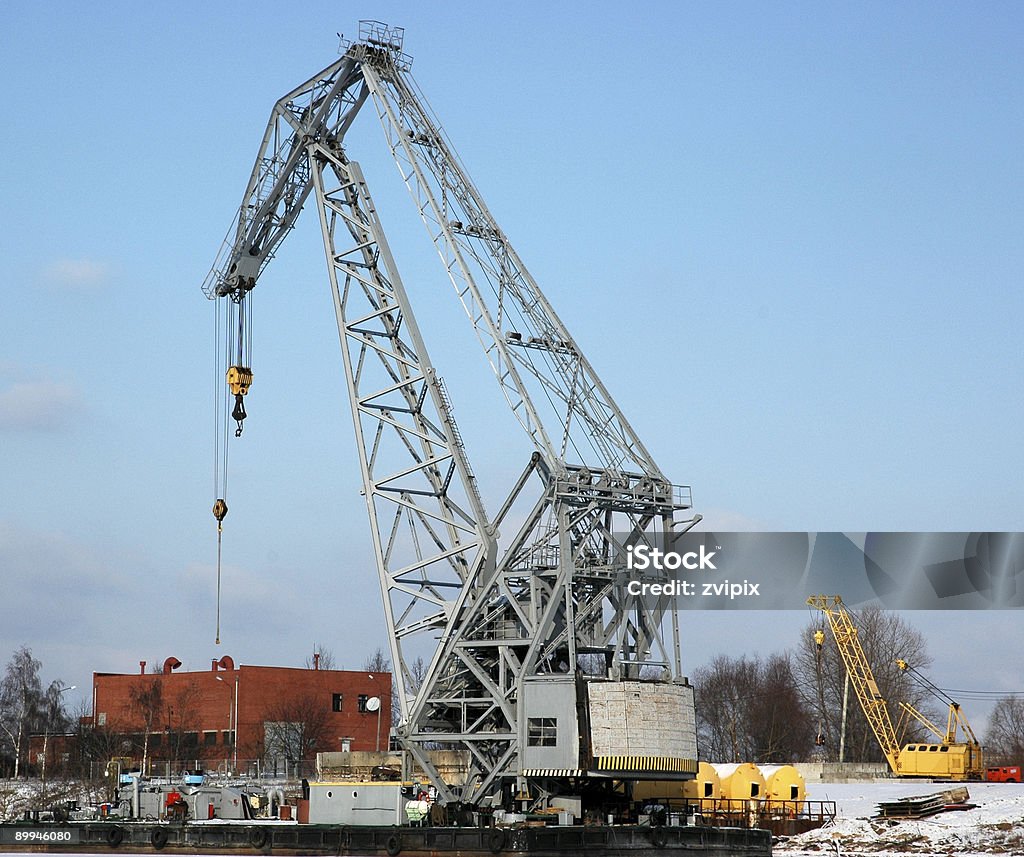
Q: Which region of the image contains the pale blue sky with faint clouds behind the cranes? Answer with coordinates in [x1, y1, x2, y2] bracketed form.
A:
[0, 2, 1024, 729]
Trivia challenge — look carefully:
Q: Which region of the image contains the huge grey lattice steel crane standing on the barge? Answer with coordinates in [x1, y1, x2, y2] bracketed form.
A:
[203, 22, 696, 805]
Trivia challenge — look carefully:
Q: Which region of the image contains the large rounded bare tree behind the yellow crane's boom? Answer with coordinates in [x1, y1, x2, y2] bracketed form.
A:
[794, 606, 937, 762]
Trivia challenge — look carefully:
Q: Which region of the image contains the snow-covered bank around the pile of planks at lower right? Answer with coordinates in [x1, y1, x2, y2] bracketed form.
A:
[772, 782, 1024, 857]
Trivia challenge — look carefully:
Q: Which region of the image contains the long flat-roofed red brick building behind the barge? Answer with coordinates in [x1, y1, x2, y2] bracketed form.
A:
[91, 656, 391, 767]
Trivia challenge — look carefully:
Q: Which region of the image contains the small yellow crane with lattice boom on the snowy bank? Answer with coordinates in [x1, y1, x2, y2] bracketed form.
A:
[807, 595, 985, 781]
